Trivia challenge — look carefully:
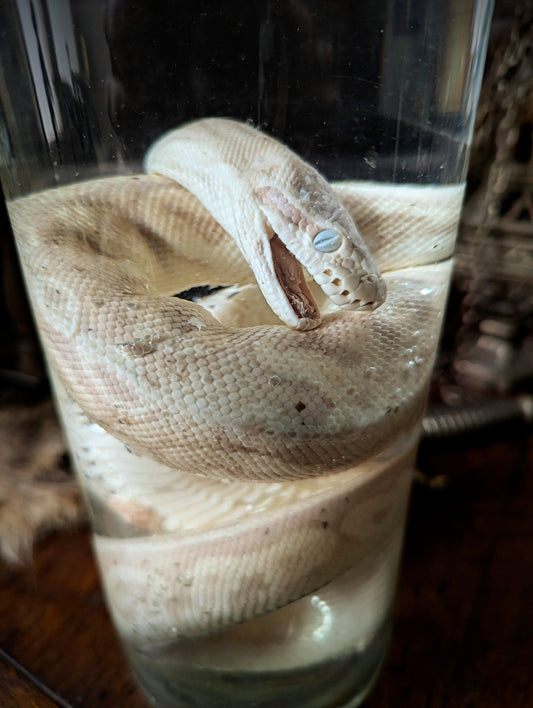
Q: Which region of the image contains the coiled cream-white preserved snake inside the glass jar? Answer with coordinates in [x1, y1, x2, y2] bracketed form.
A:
[8, 118, 462, 641]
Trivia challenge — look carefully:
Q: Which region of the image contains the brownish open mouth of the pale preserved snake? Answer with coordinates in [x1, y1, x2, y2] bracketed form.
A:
[270, 234, 320, 329]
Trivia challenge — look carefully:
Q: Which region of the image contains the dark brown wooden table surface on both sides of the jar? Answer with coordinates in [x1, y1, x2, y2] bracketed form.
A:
[0, 424, 533, 708]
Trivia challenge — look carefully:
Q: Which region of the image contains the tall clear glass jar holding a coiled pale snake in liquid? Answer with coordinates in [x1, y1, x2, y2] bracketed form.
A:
[0, 0, 491, 708]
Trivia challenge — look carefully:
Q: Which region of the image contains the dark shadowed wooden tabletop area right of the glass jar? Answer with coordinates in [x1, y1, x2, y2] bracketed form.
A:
[368, 438, 533, 708]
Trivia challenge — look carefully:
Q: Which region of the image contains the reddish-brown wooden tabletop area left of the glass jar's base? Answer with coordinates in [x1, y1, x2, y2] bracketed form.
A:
[0, 530, 147, 708]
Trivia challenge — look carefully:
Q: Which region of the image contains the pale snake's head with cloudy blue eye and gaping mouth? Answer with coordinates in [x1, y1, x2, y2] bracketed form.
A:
[256, 162, 385, 329]
